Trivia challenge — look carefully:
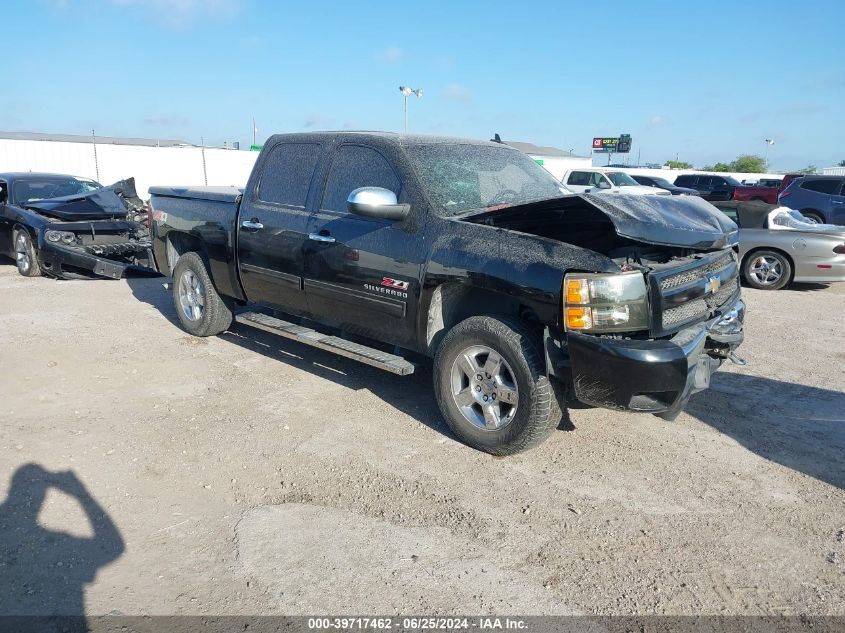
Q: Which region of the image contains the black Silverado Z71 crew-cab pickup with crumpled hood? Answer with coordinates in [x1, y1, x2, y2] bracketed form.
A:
[150, 132, 745, 454]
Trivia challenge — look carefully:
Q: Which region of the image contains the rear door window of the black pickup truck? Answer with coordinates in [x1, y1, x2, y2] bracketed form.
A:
[257, 143, 320, 207]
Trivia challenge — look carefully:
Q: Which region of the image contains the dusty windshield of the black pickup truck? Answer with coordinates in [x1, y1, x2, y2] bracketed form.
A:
[406, 143, 566, 217]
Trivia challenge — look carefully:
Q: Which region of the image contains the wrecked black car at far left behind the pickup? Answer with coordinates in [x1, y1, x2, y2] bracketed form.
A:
[0, 172, 153, 279]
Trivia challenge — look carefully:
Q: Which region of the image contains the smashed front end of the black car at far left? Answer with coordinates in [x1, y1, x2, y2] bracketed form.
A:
[26, 188, 154, 279]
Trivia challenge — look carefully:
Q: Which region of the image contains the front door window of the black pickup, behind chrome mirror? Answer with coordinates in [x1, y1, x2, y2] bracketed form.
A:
[320, 145, 402, 213]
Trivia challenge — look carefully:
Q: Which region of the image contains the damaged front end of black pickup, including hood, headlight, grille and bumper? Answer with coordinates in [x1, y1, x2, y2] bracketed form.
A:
[470, 195, 745, 419]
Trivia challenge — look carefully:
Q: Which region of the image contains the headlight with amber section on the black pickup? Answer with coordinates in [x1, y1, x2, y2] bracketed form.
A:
[563, 272, 649, 332]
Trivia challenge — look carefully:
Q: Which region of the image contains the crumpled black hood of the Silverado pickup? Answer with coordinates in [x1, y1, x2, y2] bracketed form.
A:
[466, 193, 739, 250]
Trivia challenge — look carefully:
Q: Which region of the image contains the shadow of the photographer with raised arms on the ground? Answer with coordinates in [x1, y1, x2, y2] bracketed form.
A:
[0, 464, 124, 632]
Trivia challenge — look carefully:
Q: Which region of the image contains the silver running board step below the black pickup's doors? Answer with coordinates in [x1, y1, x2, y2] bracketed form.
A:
[235, 312, 415, 376]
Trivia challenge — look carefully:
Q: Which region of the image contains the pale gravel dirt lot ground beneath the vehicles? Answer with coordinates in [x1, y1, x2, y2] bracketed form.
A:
[0, 261, 845, 614]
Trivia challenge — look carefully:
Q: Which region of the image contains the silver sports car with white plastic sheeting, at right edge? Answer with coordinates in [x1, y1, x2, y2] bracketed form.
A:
[720, 203, 845, 290]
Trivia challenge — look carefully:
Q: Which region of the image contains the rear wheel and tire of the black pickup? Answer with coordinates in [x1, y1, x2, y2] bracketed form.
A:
[173, 253, 232, 336]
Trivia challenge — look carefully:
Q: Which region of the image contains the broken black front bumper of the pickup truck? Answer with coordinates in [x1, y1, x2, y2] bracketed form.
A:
[567, 299, 745, 419]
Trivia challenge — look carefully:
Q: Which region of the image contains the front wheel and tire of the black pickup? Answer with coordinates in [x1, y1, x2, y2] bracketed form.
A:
[434, 316, 562, 455]
